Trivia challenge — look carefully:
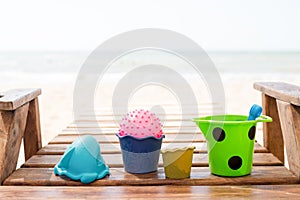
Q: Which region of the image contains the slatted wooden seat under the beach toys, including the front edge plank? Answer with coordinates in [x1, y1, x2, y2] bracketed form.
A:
[0, 83, 300, 199]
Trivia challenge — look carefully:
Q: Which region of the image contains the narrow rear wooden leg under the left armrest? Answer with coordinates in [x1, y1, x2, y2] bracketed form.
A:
[23, 98, 42, 160]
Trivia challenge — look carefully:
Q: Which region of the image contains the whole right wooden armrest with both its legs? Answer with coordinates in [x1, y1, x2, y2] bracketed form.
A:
[254, 82, 300, 178]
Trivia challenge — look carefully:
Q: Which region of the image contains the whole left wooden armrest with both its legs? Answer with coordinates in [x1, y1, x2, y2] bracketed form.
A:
[0, 89, 42, 183]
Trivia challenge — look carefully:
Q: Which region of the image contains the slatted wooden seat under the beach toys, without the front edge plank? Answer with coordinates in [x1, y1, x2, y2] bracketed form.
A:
[3, 107, 298, 186]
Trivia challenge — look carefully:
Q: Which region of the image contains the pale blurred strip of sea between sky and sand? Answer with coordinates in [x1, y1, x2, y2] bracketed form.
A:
[0, 51, 300, 79]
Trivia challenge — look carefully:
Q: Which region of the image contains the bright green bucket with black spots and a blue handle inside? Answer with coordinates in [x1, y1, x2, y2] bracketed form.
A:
[193, 115, 272, 177]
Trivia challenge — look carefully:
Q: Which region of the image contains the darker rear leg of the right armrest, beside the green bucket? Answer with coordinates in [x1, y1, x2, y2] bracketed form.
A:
[262, 94, 284, 163]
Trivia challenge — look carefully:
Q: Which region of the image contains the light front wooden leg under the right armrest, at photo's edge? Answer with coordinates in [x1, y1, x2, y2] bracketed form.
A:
[277, 100, 300, 179]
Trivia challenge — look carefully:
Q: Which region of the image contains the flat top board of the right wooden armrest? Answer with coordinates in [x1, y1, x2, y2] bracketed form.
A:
[254, 82, 300, 106]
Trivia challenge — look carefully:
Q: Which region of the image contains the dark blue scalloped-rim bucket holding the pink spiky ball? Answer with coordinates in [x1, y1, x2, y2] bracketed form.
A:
[116, 134, 165, 174]
